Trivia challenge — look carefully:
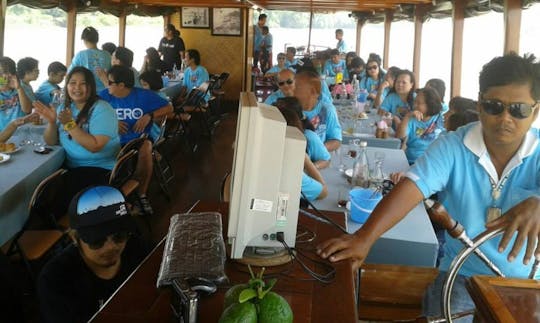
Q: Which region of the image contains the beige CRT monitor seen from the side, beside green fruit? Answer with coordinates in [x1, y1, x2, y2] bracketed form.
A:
[227, 93, 306, 259]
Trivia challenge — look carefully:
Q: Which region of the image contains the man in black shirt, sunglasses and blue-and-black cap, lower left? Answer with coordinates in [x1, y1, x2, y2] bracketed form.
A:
[37, 186, 147, 323]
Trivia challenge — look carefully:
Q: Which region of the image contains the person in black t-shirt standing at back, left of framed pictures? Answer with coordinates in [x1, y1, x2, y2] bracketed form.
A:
[158, 24, 186, 72]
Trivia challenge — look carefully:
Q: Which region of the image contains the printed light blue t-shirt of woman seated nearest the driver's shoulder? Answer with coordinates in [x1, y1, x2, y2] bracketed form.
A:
[405, 114, 444, 165]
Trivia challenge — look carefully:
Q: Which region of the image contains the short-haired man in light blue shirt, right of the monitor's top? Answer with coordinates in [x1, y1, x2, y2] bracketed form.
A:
[294, 70, 341, 152]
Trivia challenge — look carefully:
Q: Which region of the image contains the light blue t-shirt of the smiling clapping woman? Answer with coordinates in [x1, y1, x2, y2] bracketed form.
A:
[56, 100, 120, 169]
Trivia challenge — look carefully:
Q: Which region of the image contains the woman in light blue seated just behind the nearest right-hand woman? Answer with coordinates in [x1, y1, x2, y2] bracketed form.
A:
[379, 70, 415, 129]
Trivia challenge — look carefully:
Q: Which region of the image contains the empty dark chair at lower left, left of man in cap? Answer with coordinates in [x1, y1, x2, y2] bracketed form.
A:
[6, 169, 69, 280]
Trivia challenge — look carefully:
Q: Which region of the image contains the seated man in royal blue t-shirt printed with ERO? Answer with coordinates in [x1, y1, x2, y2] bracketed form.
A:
[99, 65, 173, 215]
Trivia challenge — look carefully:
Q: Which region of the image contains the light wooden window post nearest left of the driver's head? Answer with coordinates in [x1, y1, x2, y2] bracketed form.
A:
[450, 0, 467, 98]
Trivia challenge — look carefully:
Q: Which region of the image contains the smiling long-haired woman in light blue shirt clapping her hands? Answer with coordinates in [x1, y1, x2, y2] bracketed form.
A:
[34, 66, 120, 178]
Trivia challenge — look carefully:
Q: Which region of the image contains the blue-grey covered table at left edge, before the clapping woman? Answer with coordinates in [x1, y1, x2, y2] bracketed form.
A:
[0, 124, 65, 245]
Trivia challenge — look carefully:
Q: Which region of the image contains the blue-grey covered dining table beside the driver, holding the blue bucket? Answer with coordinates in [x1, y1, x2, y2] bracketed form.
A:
[313, 145, 438, 267]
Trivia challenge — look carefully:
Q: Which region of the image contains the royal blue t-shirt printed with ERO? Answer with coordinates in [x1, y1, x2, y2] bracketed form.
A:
[99, 87, 169, 145]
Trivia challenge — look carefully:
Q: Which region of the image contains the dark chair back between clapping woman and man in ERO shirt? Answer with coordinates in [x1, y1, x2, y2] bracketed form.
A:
[109, 149, 139, 197]
